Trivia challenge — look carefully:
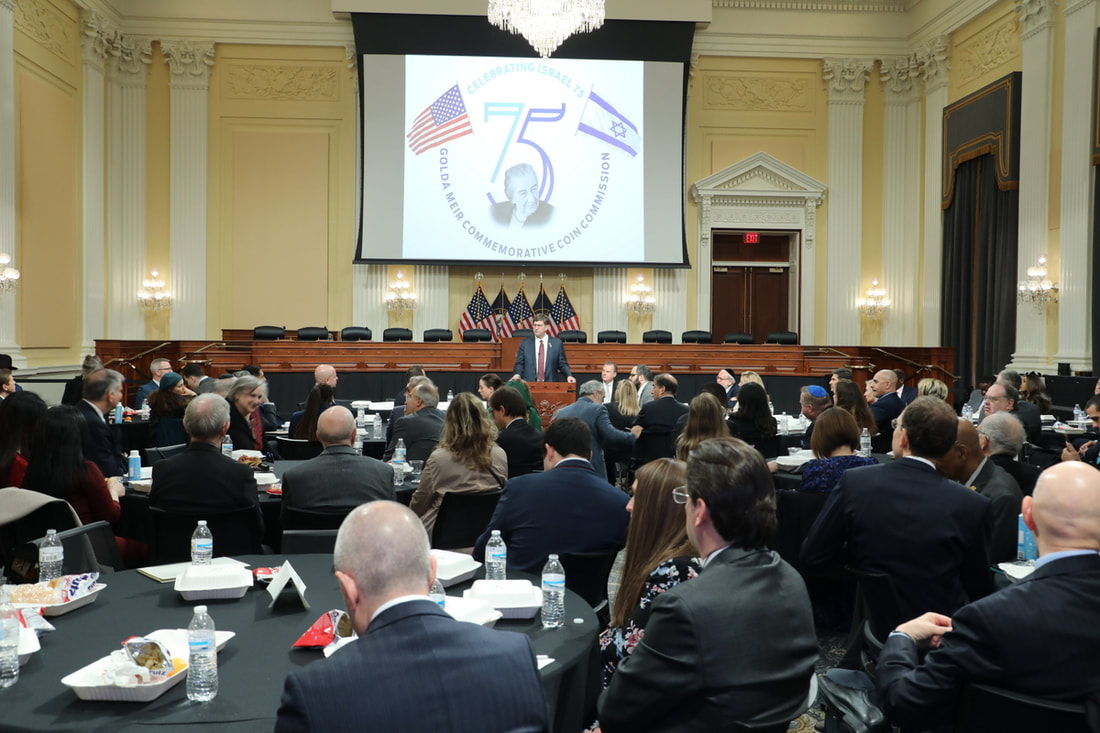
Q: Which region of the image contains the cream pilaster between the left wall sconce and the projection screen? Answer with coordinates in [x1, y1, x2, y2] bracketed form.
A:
[161, 41, 213, 339]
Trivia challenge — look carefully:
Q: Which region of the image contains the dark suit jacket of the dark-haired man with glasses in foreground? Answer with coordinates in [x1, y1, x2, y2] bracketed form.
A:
[600, 547, 817, 733]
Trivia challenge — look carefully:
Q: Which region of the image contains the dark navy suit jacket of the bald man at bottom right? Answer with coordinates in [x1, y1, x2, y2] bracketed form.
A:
[875, 553, 1100, 729]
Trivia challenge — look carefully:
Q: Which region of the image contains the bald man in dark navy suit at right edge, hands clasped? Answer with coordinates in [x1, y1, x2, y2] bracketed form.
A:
[877, 462, 1100, 729]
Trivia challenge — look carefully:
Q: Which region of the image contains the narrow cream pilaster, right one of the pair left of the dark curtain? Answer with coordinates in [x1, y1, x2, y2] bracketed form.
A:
[914, 35, 950, 347]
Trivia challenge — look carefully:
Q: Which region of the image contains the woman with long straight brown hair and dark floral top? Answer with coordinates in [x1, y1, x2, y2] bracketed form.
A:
[600, 457, 699, 687]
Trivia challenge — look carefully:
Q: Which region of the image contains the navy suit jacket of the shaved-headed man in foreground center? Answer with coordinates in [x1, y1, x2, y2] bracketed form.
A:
[275, 600, 547, 733]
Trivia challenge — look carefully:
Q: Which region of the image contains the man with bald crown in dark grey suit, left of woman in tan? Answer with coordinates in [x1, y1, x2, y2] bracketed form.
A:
[282, 405, 394, 521]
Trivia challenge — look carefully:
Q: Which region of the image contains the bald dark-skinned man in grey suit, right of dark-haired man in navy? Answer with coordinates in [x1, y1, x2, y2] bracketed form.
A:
[937, 418, 1024, 564]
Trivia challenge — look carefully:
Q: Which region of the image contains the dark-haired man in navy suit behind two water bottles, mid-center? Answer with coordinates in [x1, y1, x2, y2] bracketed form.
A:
[473, 417, 630, 575]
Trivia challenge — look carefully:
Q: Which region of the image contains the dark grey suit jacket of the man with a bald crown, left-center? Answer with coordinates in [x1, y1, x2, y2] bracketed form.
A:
[282, 446, 394, 517]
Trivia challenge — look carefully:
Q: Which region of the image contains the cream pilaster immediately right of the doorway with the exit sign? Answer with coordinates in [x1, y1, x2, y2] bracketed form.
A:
[825, 58, 875, 346]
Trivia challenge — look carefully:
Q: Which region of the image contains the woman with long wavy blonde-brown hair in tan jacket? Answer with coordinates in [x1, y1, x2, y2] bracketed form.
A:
[409, 392, 508, 537]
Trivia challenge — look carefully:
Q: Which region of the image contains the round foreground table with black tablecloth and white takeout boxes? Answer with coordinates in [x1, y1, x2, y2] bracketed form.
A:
[0, 555, 600, 733]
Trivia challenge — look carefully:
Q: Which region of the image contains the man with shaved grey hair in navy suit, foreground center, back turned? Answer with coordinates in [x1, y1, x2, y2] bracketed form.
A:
[275, 502, 547, 733]
